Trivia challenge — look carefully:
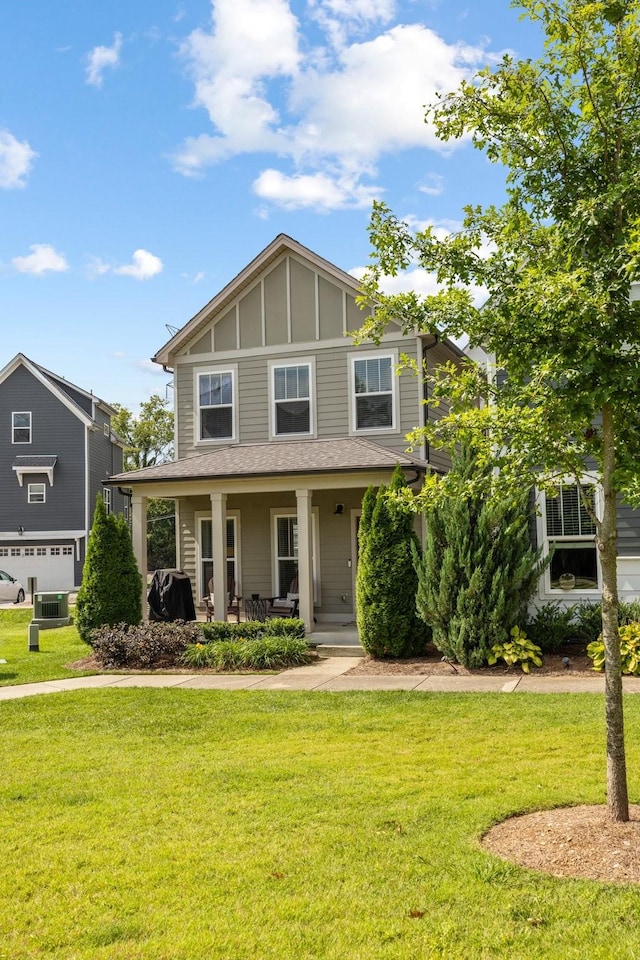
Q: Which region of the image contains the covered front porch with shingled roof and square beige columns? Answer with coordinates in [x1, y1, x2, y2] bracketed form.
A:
[109, 438, 425, 634]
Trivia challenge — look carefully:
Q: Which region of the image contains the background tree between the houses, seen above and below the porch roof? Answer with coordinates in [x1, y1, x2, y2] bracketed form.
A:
[111, 395, 176, 570]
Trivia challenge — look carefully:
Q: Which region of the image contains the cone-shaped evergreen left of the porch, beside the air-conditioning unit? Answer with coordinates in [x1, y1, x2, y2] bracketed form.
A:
[75, 495, 142, 643]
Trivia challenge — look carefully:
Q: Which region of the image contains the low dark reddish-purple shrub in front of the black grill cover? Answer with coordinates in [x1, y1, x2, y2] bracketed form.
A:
[91, 621, 202, 670]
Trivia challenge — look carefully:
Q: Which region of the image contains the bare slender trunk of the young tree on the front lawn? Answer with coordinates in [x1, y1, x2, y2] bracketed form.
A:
[596, 405, 629, 821]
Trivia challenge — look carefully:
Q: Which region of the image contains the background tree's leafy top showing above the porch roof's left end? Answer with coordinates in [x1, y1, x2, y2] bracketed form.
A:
[111, 395, 173, 470]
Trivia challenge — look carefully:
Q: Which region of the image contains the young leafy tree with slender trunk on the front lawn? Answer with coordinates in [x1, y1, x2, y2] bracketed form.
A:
[361, 0, 640, 820]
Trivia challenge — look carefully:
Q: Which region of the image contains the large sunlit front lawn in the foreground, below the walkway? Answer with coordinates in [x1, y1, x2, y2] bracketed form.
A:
[0, 689, 640, 960]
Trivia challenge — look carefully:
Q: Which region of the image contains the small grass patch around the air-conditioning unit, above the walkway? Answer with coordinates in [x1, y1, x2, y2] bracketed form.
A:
[0, 607, 96, 688]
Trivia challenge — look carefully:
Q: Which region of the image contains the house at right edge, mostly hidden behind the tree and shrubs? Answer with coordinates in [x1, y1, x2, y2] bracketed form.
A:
[470, 344, 640, 604]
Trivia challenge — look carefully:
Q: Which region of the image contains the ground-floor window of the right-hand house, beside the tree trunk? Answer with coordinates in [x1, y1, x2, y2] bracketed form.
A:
[544, 482, 600, 592]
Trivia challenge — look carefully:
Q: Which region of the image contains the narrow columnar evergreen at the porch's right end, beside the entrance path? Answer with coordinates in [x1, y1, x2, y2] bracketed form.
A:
[356, 465, 429, 657]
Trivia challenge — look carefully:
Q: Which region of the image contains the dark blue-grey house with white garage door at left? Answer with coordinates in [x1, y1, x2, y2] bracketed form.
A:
[0, 353, 128, 590]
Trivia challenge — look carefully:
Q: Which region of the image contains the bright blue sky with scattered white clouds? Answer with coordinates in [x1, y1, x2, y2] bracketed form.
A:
[0, 0, 541, 412]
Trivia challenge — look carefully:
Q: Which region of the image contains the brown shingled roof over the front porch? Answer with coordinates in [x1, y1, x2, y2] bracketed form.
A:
[109, 437, 427, 486]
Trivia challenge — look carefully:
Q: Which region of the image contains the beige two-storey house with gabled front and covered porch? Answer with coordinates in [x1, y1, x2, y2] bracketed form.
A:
[110, 234, 463, 626]
